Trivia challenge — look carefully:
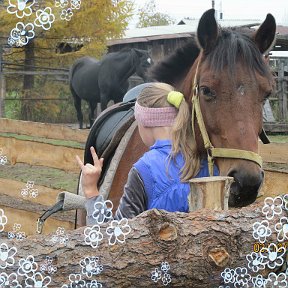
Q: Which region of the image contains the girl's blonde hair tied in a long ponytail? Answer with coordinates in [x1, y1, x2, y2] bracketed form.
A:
[137, 82, 200, 182]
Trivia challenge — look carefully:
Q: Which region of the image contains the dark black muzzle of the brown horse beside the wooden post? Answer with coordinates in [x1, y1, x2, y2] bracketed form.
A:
[228, 167, 264, 207]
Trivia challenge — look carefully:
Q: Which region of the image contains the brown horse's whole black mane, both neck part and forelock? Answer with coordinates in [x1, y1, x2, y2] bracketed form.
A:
[148, 27, 272, 86]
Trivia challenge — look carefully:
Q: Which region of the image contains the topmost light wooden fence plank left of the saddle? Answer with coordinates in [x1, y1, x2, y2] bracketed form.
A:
[0, 118, 89, 143]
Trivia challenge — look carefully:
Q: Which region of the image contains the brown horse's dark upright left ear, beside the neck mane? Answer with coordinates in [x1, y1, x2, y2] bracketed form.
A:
[197, 9, 218, 53]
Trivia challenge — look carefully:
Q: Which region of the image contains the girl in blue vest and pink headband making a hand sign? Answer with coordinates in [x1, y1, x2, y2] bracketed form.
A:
[76, 83, 218, 225]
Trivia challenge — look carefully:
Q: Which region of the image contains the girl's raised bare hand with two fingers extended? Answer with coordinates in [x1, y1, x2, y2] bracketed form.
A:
[76, 147, 104, 198]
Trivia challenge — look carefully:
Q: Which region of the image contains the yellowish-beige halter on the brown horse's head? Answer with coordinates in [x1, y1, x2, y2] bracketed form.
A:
[192, 55, 262, 176]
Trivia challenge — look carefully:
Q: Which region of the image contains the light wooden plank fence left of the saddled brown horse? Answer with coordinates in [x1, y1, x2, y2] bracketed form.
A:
[0, 119, 89, 235]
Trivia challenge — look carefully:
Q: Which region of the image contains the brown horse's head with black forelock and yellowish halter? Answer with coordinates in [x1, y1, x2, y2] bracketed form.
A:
[183, 9, 276, 207]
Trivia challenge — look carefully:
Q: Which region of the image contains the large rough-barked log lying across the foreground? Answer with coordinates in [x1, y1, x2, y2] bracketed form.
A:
[0, 202, 284, 288]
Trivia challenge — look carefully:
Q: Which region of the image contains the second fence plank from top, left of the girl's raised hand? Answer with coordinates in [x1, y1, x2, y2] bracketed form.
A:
[0, 136, 83, 172]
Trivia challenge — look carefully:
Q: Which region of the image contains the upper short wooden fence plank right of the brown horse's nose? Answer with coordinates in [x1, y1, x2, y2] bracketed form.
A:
[259, 143, 288, 164]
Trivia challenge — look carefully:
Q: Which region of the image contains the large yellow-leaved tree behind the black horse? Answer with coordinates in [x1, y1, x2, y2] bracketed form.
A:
[0, 0, 133, 120]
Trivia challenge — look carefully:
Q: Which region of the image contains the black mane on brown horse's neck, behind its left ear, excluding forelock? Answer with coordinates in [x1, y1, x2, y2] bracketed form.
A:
[148, 37, 200, 86]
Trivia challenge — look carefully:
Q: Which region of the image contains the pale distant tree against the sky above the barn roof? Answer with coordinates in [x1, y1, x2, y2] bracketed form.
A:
[136, 0, 175, 28]
